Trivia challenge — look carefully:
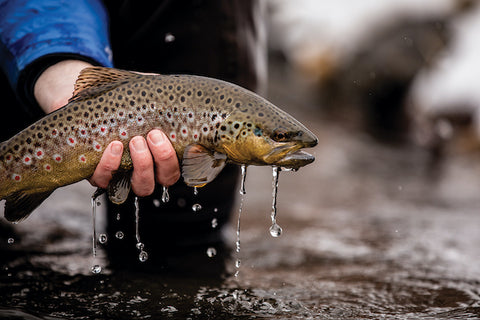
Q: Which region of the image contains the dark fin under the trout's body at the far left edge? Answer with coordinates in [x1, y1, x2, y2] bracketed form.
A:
[5, 190, 53, 223]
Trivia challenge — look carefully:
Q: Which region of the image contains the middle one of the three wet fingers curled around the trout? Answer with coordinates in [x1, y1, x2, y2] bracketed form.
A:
[129, 136, 155, 197]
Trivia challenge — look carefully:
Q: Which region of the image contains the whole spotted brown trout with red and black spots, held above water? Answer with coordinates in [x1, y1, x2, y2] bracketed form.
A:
[0, 67, 317, 222]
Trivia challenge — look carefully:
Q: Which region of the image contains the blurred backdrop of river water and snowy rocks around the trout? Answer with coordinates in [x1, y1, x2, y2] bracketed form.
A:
[0, 0, 480, 319]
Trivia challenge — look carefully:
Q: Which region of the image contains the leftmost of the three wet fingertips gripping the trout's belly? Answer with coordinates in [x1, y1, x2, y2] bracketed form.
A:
[89, 141, 123, 189]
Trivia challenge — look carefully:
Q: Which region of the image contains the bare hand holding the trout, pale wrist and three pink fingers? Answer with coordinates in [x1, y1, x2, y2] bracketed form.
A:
[34, 60, 180, 196]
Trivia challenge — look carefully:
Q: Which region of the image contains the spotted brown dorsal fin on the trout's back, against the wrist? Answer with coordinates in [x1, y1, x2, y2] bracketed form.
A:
[68, 67, 140, 102]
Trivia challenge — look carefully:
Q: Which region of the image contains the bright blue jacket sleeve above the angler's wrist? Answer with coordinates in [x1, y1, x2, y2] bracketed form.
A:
[0, 0, 112, 90]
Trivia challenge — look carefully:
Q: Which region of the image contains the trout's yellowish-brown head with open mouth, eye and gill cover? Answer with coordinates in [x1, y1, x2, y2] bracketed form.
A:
[220, 96, 318, 169]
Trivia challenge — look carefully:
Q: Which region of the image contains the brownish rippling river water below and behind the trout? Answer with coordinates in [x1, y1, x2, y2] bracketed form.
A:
[0, 66, 480, 320]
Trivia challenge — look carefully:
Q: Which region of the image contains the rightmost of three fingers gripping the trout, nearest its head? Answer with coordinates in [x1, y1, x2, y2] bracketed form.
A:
[147, 130, 180, 187]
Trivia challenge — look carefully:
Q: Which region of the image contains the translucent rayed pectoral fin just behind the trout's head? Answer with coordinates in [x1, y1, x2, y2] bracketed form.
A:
[182, 144, 227, 187]
